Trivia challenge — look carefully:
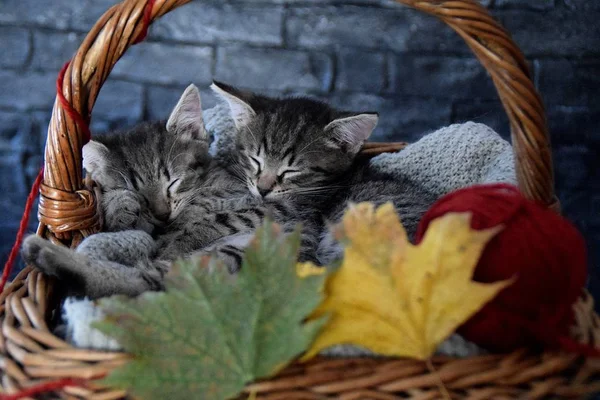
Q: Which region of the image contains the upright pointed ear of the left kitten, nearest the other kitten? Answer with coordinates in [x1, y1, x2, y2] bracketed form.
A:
[167, 84, 208, 140]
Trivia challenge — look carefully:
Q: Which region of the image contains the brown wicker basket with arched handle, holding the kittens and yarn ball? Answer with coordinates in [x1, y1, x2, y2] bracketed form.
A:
[0, 0, 600, 400]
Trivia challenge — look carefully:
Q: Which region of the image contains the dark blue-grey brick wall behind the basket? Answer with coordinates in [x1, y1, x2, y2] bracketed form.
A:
[0, 0, 600, 295]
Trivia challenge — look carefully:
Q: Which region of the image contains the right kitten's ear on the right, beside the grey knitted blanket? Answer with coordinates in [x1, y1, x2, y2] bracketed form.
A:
[325, 113, 379, 154]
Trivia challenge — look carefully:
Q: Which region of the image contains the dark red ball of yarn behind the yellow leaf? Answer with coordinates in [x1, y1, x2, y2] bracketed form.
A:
[416, 184, 587, 352]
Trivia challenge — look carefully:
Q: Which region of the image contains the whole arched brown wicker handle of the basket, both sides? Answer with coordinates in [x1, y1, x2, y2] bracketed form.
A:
[38, 0, 555, 246]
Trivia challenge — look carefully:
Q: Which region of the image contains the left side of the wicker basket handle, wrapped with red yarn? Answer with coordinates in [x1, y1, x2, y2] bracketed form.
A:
[38, 0, 191, 246]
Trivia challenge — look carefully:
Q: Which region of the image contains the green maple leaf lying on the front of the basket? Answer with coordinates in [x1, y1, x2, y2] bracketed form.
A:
[95, 222, 324, 400]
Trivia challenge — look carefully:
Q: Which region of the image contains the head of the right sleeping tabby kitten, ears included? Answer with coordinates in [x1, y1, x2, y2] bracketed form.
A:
[211, 82, 378, 202]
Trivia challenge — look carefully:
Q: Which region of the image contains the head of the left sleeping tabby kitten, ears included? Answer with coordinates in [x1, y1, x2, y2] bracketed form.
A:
[83, 85, 211, 233]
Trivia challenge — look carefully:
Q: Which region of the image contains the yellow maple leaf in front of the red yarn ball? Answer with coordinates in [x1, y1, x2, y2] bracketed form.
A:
[304, 203, 512, 360]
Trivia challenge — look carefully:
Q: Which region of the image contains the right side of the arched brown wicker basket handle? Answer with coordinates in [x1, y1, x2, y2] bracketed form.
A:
[396, 0, 559, 210]
